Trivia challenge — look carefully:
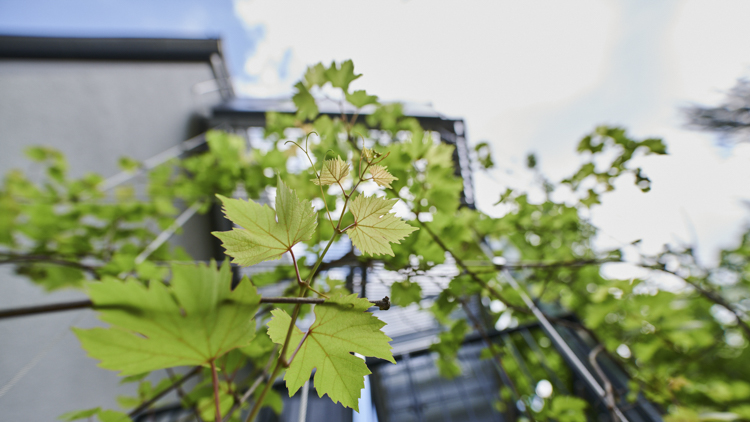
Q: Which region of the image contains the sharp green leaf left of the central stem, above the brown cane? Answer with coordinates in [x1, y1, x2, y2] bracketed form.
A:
[212, 180, 317, 266]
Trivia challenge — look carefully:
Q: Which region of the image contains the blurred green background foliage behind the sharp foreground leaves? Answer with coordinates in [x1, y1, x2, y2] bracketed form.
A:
[0, 62, 750, 421]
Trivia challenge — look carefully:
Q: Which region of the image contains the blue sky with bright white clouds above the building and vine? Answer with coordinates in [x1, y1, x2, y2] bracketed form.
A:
[0, 0, 750, 263]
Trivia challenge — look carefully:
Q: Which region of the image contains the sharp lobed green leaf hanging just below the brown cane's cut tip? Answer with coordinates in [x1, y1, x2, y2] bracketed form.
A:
[268, 295, 396, 411]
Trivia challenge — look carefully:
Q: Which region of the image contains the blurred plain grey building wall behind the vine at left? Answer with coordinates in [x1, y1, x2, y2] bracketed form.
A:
[0, 60, 220, 421]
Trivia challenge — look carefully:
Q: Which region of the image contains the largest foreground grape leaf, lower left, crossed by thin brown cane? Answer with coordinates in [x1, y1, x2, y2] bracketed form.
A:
[73, 262, 260, 375]
